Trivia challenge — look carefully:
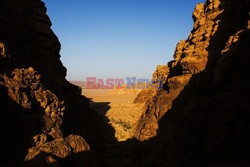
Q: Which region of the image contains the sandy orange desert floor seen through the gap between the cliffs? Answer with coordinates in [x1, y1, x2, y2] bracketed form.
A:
[82, 86, 144, 141]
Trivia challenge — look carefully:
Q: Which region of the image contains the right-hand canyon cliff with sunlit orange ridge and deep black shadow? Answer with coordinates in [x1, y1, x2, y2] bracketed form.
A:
[134, 0, 250, 166]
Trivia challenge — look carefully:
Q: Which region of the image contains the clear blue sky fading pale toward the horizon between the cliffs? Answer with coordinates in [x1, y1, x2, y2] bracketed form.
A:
[43, 0, 205, 81]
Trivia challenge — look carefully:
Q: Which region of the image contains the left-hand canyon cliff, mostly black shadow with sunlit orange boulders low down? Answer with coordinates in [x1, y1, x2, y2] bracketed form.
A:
[0, 0, 90, 166]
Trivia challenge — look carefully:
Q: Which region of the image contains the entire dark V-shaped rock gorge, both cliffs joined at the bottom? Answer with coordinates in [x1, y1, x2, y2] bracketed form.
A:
[0, 0, 250, 167]
